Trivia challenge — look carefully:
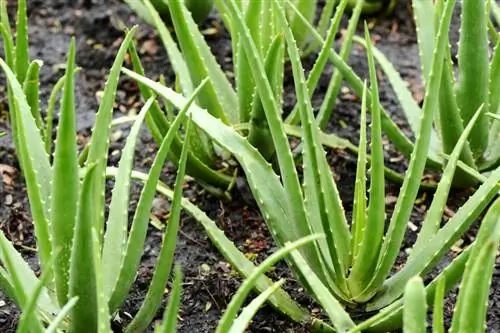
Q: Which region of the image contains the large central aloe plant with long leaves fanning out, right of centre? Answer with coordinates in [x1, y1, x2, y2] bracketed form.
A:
[124, 0, 500, 332]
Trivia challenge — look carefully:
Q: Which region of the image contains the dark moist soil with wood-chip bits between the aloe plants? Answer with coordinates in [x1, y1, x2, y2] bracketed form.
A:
[0, 0, 500, 333]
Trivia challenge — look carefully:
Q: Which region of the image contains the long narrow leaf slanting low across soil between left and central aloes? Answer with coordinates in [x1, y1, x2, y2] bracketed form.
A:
[117, 167, 311, 323]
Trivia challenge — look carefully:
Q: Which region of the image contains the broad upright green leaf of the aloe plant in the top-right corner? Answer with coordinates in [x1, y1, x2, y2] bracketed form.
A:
[457, 0, 488, 158]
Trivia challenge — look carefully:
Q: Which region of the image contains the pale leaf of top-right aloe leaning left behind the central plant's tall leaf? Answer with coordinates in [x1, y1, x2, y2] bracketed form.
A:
[354, 36, 445, 163]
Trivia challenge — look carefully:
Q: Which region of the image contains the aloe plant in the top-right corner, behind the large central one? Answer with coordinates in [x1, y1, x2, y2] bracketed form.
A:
[342, 0, 500, 186]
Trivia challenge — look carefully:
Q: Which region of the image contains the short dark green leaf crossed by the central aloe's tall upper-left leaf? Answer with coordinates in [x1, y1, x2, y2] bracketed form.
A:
[247, 34, 285, 161]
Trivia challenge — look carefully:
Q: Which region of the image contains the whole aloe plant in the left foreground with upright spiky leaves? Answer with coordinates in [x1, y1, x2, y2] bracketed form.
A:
[0, 14, 212, 332]
